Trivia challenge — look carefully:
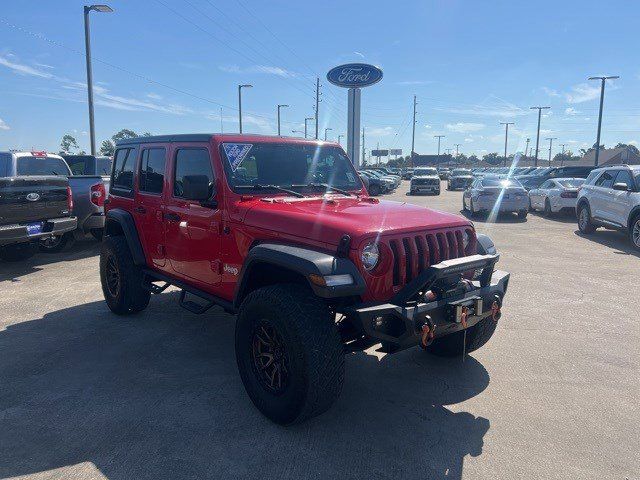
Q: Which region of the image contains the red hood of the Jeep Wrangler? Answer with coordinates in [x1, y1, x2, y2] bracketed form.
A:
[238, 195, 470, 248]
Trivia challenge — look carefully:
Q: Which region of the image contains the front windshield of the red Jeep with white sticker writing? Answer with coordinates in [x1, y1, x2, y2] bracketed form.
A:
[221, 143, 362, 193]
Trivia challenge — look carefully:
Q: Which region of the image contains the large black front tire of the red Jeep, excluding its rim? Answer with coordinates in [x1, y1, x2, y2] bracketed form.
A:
[235, 284, 344, 425]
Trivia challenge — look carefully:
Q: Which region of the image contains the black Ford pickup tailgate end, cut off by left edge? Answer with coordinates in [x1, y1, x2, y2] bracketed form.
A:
[0, 152, 77, 261]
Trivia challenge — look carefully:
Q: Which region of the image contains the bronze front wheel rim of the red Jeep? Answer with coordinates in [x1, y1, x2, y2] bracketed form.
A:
[251, 320, 289, 395]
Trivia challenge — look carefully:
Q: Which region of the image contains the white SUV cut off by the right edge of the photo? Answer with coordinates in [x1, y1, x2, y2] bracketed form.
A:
[576, 165, 640, 250]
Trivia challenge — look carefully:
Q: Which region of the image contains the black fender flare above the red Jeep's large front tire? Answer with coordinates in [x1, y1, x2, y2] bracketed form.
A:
[234, 243, 366, 308]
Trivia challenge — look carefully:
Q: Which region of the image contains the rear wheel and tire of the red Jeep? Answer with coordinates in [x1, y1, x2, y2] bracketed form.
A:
[100, 236, 151, 315]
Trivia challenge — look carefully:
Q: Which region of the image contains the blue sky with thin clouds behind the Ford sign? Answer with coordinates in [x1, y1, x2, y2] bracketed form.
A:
[0, 0, 640, 157]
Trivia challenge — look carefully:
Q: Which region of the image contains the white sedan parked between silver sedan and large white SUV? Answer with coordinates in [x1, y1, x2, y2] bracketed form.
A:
[529, 178, 584, 217]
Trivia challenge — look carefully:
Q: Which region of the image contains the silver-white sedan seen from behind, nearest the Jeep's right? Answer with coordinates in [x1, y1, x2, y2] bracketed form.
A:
[462, 176, 529, 219]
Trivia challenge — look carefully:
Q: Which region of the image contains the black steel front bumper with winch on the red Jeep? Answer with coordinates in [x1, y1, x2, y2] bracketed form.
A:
[350, 254, 509, 352]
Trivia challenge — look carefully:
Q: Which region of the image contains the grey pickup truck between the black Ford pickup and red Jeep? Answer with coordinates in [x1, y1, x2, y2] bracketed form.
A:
[4, 152, 107, 253]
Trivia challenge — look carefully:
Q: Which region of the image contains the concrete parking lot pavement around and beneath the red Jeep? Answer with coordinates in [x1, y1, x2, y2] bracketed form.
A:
[0, 181, 640, 480]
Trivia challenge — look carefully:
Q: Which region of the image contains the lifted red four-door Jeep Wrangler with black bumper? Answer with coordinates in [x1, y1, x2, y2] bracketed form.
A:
[100, 134, 509, 424]
